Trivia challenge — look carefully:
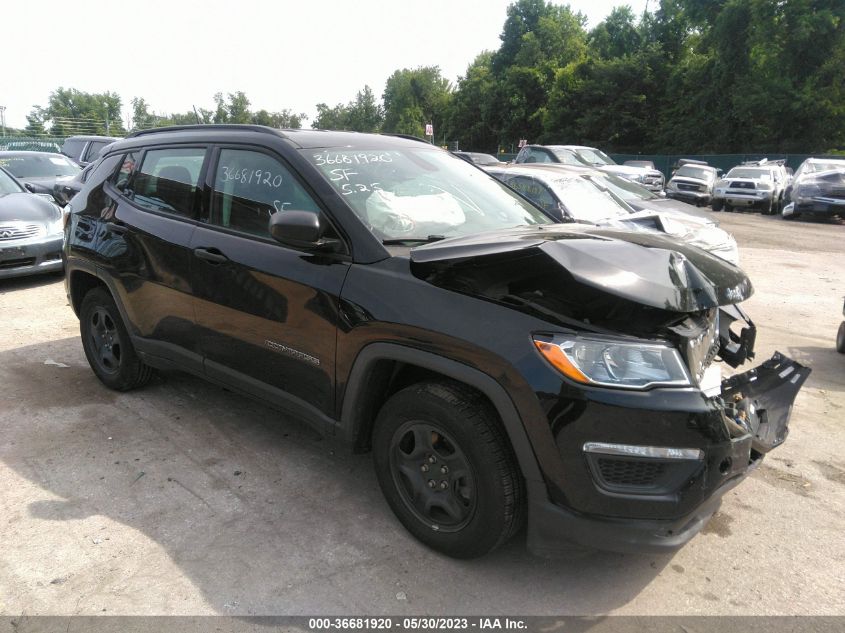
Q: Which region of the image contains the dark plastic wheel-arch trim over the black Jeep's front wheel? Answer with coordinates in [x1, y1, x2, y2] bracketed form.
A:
[337, 343, 543, 490]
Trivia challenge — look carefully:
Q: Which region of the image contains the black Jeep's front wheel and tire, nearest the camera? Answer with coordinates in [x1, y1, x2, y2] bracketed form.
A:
[373, 382, 525, 558]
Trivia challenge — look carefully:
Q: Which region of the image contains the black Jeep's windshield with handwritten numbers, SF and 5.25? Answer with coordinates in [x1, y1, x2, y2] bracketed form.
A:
[304, 147, 552, 242]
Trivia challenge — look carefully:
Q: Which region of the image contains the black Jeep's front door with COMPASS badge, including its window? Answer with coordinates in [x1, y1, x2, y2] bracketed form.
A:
[191, 145, 349, 424]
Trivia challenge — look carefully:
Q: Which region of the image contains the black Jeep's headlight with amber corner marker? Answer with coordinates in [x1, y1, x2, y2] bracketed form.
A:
[534, 336, 692, 389]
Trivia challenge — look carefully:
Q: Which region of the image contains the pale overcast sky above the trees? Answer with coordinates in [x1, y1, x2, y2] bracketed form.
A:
[0, 0, 657, 127]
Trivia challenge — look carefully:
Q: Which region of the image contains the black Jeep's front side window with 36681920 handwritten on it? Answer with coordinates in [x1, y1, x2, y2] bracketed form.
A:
[211, 149, 319, 237]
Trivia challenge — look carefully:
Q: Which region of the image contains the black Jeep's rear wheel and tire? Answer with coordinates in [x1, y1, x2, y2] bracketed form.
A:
[79, 288, 153, 391]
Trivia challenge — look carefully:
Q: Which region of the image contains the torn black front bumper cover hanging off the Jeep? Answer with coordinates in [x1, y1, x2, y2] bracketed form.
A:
[528, 353, 810, 552]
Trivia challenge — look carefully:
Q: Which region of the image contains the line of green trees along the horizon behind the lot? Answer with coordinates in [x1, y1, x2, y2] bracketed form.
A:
[11, 0, 845, 153]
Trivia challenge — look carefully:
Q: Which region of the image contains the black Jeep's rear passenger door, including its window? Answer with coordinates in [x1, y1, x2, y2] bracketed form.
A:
[98, 145, 208, 372]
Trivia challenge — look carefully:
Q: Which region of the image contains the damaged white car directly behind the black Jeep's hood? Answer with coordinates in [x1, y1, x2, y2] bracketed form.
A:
[486, 165, 739, 265]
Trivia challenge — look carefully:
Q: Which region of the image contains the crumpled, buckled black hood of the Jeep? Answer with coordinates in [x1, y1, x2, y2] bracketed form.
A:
[410, 224, 753, 312]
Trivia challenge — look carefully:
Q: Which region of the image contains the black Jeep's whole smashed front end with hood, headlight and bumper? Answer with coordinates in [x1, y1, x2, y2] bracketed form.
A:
[411, 226, 810, 550]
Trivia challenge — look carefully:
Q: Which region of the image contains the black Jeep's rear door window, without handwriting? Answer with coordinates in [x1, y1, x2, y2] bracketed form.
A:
[132, 147, 205, 218]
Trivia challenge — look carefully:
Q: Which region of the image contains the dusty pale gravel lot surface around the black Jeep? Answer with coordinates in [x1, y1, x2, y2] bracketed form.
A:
[0, 213, 845, 615]
